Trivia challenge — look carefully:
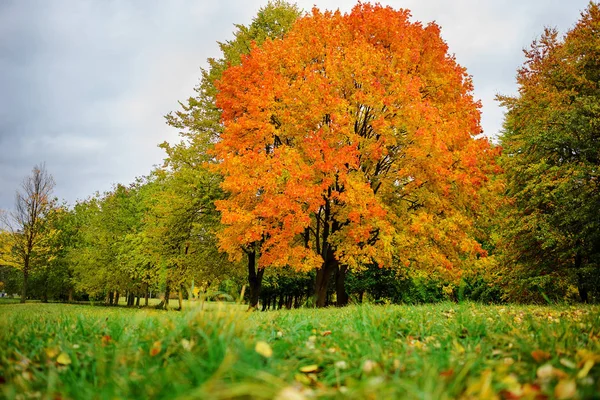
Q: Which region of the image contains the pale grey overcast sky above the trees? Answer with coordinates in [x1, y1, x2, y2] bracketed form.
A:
[0, 0, 588, 209]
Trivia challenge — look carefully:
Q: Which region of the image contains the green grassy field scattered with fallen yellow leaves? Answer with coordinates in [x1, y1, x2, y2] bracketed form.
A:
[0, 303, 600, 400]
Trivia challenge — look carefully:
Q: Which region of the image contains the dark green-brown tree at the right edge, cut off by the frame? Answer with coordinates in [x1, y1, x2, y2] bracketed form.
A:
[500, 3, 600, 301]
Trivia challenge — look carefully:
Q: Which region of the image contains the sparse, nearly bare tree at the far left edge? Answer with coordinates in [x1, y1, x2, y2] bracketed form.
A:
[0, 163, 55, 303]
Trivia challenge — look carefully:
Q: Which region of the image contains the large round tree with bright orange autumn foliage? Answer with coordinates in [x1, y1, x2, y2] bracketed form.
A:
[215, 4, 494, 306]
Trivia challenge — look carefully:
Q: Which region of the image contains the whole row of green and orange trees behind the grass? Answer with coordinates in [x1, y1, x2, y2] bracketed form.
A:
[0, 1, 600, 310]
